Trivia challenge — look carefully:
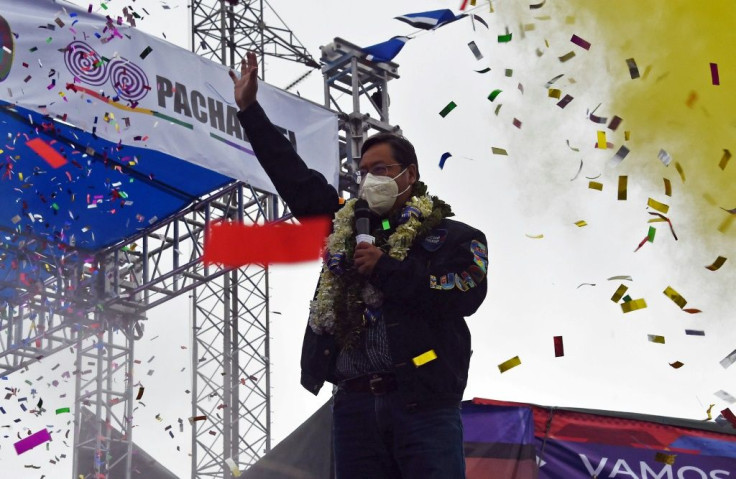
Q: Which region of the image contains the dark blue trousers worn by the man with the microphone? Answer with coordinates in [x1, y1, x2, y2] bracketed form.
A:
[332, 390, 465, 479]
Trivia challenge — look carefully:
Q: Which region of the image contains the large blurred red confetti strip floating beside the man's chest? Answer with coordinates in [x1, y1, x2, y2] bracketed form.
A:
[202, 217, 330, 267]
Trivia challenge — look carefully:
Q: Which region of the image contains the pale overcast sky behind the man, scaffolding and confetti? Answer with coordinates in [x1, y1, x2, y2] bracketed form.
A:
[0, 0, 736, 477]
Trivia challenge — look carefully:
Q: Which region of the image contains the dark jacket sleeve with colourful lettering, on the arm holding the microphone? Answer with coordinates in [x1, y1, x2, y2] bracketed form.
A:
[370, 227, 488, 317]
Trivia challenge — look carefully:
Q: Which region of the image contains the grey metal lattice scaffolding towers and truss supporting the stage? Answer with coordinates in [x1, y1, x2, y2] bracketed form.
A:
[0, 5, 400, 479]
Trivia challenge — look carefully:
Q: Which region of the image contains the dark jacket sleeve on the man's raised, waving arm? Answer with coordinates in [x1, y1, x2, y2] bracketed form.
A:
[238, 102, 339, 219]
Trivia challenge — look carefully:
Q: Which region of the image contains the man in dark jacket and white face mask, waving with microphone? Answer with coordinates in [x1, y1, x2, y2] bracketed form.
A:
[230, 52, 488, 479]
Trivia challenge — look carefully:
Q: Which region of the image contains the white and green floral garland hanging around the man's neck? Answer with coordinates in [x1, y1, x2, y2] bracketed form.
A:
[309, 181, 453, 348]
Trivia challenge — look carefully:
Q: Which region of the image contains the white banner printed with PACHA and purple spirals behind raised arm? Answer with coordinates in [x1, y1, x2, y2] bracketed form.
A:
[0, 0, 339, 192]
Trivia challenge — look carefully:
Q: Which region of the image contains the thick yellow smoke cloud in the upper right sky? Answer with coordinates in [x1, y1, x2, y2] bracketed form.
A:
[548, 0, 736, 237]
